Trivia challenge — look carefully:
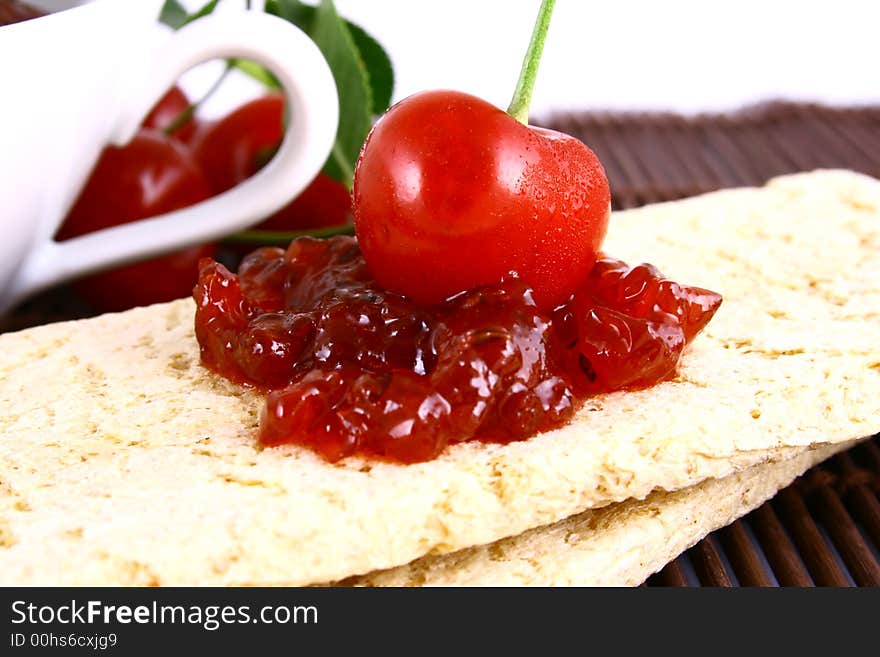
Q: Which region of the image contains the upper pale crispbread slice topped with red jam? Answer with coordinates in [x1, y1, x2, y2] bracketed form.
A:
[0, 172, 880, 584]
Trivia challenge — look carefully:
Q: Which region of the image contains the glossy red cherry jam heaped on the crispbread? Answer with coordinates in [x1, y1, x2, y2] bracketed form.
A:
[194, 237, 721, 463]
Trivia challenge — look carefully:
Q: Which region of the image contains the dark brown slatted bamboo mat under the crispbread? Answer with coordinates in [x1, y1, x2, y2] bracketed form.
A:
[0, 0, 880, 586]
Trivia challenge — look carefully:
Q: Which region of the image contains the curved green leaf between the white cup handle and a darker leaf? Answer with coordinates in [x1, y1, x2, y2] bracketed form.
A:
[310, 0, 373, 188]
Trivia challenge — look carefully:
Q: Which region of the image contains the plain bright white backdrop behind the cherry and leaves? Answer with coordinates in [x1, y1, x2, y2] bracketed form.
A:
[31, 0, 880, 116]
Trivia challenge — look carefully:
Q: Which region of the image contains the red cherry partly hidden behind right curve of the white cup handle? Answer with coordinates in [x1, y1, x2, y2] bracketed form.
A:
[193, 94, 351, 230]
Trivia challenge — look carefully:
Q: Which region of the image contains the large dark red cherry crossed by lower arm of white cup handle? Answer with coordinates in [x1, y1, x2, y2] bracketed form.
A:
[57, 130, 216, 312]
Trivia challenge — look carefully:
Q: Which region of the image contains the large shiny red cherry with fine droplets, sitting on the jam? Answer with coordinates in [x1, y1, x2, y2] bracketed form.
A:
[353, 91, 611, 309]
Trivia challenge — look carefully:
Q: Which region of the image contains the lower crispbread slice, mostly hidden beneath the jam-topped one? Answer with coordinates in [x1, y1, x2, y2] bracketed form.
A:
[338, 443, 851, 586]
